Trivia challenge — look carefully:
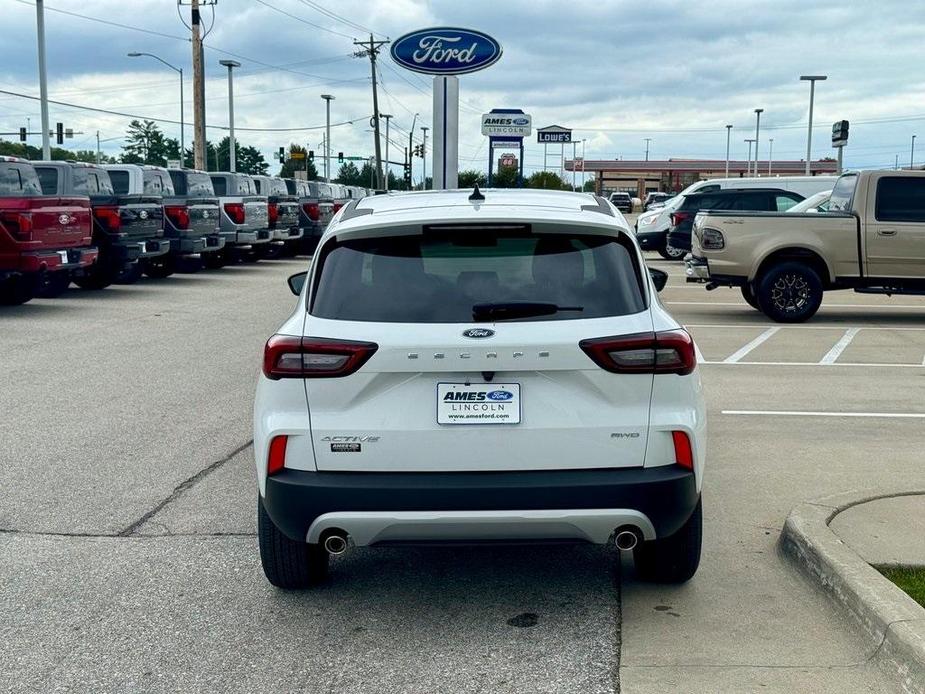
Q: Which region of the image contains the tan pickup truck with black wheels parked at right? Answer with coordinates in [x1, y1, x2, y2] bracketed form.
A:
[687, 171, 925, 323]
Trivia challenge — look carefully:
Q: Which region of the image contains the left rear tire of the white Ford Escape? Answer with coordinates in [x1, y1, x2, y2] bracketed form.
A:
[257, 497, 328, 590]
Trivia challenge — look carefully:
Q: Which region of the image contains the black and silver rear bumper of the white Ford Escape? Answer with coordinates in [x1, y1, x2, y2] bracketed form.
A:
[263, 465, 699, 544]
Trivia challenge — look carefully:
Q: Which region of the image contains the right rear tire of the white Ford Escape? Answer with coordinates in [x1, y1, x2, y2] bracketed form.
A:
[633, 501, 703, 583]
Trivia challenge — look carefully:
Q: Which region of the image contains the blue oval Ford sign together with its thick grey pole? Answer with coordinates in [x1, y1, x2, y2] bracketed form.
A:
[390, 27, 501, 189]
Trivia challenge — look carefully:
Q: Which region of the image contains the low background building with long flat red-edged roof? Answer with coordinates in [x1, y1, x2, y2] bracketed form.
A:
[565, 159, 838, 198]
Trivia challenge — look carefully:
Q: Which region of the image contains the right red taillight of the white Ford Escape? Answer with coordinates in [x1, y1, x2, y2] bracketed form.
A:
[578, 330, 697, 376]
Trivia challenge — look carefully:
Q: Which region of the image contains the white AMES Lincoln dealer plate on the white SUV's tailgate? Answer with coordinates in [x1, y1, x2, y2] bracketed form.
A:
[437, 383, 520, 424]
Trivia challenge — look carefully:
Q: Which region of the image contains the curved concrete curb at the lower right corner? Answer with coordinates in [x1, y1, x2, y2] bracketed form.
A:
[781, 490, 925, 694]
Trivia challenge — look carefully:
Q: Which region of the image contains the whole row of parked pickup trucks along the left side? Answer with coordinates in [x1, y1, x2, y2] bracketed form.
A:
[0, 156, 370, 305]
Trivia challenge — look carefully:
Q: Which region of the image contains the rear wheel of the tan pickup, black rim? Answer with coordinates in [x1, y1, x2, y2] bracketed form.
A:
[757, 261, 823, 323]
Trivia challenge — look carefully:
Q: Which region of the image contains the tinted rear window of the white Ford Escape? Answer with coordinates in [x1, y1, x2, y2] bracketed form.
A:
[310, 229, 645, 323]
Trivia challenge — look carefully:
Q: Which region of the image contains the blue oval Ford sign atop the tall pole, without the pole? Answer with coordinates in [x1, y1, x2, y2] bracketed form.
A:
[391, 27, 501, 75]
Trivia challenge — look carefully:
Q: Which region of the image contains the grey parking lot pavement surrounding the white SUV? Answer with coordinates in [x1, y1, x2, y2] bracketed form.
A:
[0, 235, 925, 694]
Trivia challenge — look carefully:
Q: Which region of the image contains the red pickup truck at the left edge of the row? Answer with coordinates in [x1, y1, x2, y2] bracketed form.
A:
[0, 156, 98, 306]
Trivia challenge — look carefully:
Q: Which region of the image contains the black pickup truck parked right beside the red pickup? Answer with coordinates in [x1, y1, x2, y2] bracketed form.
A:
[34, 161, 170, 289]
